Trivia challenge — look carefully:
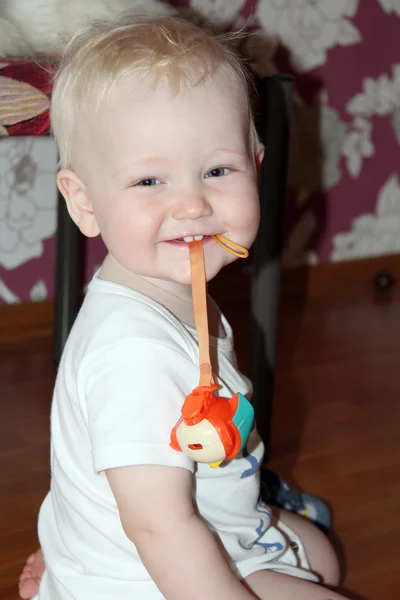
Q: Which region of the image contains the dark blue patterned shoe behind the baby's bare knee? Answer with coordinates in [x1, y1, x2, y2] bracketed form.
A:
[260, 468, 332, 533]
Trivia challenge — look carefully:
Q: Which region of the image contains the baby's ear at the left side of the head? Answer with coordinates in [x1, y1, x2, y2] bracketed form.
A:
[57, 169, 100, 237]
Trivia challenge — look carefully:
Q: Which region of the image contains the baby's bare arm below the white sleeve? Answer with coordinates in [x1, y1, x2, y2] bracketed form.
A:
[106, 465, 254, 600]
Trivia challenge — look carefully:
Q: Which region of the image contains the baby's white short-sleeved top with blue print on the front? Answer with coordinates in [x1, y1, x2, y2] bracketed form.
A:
[39, 276, 316, 600]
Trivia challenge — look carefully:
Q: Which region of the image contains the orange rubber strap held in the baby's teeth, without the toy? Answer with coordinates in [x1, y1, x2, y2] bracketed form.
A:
[189, 235, 249, 386]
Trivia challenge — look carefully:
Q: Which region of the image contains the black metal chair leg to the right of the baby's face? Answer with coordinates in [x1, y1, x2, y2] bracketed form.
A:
[250, 75, 293, 454]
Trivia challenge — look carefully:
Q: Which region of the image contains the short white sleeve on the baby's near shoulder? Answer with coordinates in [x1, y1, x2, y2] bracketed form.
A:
[82, 341, 199, 472]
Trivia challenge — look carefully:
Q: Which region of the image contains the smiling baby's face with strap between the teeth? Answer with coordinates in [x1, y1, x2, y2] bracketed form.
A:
[79, 73, 259, 283]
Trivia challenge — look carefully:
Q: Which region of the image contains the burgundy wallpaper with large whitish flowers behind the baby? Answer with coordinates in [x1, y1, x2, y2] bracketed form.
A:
[0, 0, 400, 303]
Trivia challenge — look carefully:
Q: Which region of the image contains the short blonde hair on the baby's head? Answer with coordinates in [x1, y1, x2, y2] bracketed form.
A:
[51, 17, 254, 168]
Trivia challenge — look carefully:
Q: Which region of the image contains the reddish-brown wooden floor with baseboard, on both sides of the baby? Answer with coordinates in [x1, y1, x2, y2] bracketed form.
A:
[0, 258, 400, 600]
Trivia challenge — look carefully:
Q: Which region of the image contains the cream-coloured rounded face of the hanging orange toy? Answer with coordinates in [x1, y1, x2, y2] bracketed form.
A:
[176, 419, 226, 464]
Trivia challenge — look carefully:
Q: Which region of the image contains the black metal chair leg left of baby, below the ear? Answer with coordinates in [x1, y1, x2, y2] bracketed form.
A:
[53, 192, 82, 363]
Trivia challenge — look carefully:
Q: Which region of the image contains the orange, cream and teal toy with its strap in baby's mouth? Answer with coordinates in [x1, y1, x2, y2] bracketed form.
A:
[171, 236, 254, 467]
